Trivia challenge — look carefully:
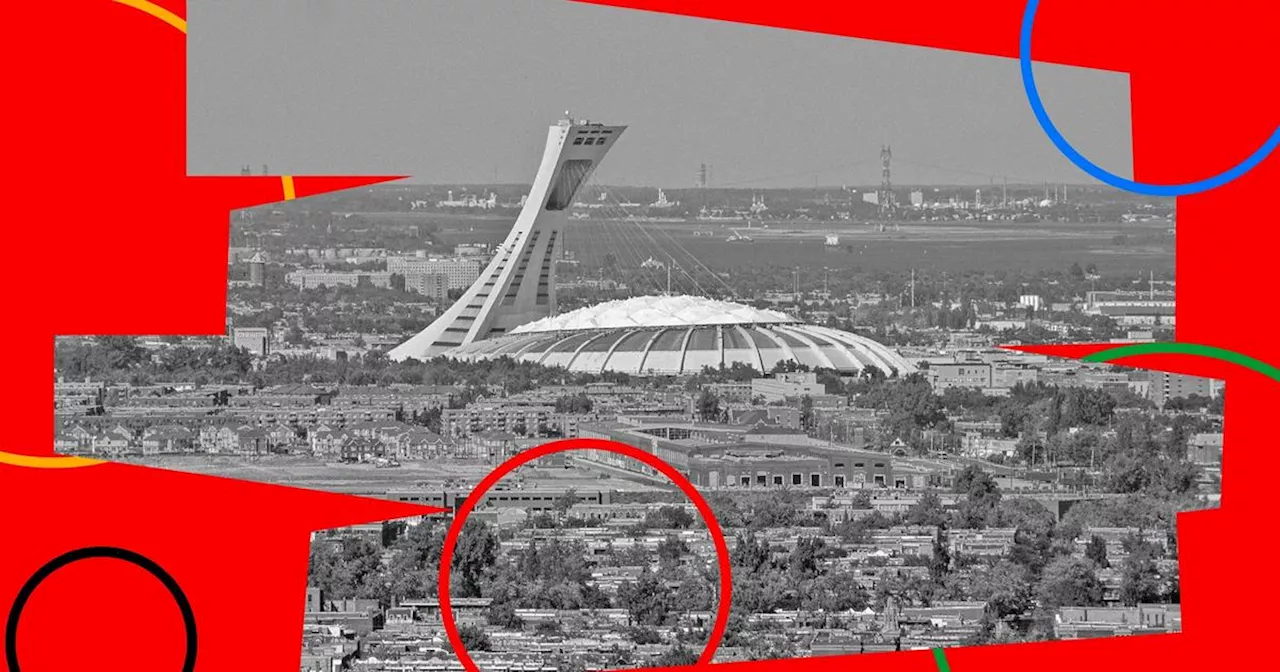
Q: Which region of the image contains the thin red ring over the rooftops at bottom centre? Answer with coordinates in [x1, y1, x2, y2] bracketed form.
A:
[439, 439, 733, 672]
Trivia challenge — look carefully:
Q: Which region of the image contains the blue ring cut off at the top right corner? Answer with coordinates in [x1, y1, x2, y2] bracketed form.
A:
[1018, 0, 1280, 196]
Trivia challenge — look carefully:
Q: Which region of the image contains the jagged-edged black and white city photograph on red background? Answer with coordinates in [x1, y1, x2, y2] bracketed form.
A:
[54, 0, 1208, 672]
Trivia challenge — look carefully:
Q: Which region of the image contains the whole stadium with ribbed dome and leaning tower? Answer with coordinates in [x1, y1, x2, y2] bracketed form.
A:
[389, 119, 915, 376]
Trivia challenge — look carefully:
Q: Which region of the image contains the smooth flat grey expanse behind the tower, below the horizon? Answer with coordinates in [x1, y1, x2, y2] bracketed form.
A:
[384, 215, 1174, 274]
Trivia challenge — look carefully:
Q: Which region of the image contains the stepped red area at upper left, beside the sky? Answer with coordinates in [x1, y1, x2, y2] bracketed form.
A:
[0, 0, 397, 454]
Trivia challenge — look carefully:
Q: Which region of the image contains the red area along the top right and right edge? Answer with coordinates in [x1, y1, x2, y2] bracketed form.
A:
[576, 0, 1280, 672]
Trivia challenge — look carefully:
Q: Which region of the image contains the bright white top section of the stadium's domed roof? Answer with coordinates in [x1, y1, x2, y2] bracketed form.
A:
[511, 296, 796, 334]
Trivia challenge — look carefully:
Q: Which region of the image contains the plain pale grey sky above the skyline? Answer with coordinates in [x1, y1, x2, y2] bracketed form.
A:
[187, 0, 1132, 188]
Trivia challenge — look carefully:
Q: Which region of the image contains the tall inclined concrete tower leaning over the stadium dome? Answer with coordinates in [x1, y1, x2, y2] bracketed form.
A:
[389, 119, 626, 360]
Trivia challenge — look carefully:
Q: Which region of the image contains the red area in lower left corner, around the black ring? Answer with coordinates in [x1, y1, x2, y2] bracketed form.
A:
[0, 458, 443, 671]
